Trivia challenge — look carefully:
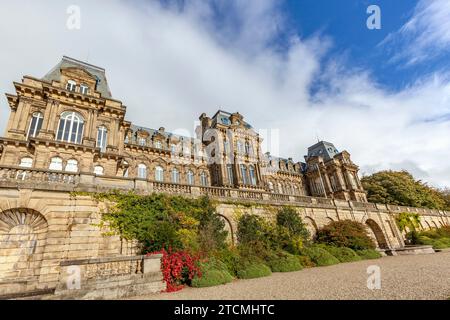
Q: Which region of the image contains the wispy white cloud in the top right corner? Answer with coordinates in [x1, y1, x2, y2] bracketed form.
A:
[381, 0, 450, 65]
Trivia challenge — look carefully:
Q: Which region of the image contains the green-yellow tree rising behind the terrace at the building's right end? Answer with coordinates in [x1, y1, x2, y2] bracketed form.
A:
[361, 171, 450, 210]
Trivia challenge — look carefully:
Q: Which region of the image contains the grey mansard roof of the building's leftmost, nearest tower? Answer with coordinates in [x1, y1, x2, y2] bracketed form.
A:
[42, 56, 112, 99]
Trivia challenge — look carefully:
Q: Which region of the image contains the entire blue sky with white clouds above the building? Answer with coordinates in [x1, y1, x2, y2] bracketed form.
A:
[0, 0, 450, 187]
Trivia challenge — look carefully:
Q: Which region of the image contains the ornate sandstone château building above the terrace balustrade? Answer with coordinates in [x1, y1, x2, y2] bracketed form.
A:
[0, 57, 366, 202]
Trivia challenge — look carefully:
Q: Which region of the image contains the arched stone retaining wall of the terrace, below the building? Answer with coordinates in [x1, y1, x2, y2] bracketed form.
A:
[0, 182, 450, 298]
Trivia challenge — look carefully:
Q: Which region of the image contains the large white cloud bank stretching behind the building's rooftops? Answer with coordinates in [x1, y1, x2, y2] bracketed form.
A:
[0, 0, 450, 185]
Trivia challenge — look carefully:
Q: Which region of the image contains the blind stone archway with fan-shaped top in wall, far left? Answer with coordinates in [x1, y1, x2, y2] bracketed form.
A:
[0, 208, 48, 286]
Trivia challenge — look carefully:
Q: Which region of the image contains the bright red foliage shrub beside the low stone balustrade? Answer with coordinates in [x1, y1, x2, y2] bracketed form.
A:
[147, 248, 201, 292]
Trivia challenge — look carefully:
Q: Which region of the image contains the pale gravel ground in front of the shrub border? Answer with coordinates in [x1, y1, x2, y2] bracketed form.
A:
[129, 251, 450, 300]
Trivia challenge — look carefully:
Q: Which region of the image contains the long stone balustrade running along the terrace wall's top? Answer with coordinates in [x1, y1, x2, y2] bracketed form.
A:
[0, 166, 450, 216]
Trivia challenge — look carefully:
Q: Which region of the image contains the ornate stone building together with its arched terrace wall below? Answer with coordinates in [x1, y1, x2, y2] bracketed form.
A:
[0, 57, 450, 299]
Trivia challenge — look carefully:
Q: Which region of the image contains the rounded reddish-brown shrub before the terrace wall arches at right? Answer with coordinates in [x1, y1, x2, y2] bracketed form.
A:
[316, 220, 375, 250]
